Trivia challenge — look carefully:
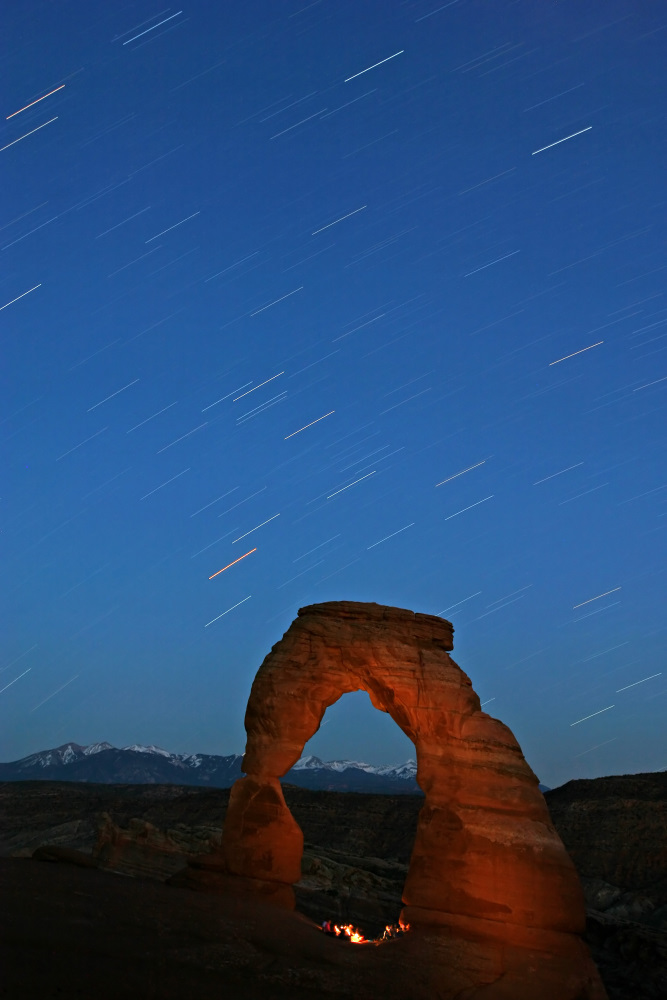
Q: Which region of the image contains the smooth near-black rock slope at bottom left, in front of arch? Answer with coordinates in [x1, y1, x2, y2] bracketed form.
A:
[0, 858, 418, 1000]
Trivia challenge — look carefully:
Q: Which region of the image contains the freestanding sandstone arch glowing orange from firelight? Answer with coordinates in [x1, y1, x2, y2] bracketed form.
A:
[220, 601, 605, 1000]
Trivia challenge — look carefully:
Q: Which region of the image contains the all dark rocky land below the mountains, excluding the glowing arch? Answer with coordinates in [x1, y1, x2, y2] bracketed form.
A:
[0, 773, 667, 1000]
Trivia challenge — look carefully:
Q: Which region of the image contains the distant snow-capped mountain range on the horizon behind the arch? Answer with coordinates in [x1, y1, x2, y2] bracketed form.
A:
[0, 743, 548, 795]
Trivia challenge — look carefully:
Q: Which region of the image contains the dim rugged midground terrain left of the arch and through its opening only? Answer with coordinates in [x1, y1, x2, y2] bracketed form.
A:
[0, 782, 423, 933]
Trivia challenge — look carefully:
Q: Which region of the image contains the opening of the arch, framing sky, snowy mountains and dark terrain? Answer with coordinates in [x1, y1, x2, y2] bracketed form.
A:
[283, 690, 423, 941]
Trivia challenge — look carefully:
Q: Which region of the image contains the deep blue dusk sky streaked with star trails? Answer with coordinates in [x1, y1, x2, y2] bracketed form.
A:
[0, 0, 667, 785]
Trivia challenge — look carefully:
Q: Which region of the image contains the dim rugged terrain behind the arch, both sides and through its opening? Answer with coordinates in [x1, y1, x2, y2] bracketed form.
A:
[0, 772, 667, 988]
